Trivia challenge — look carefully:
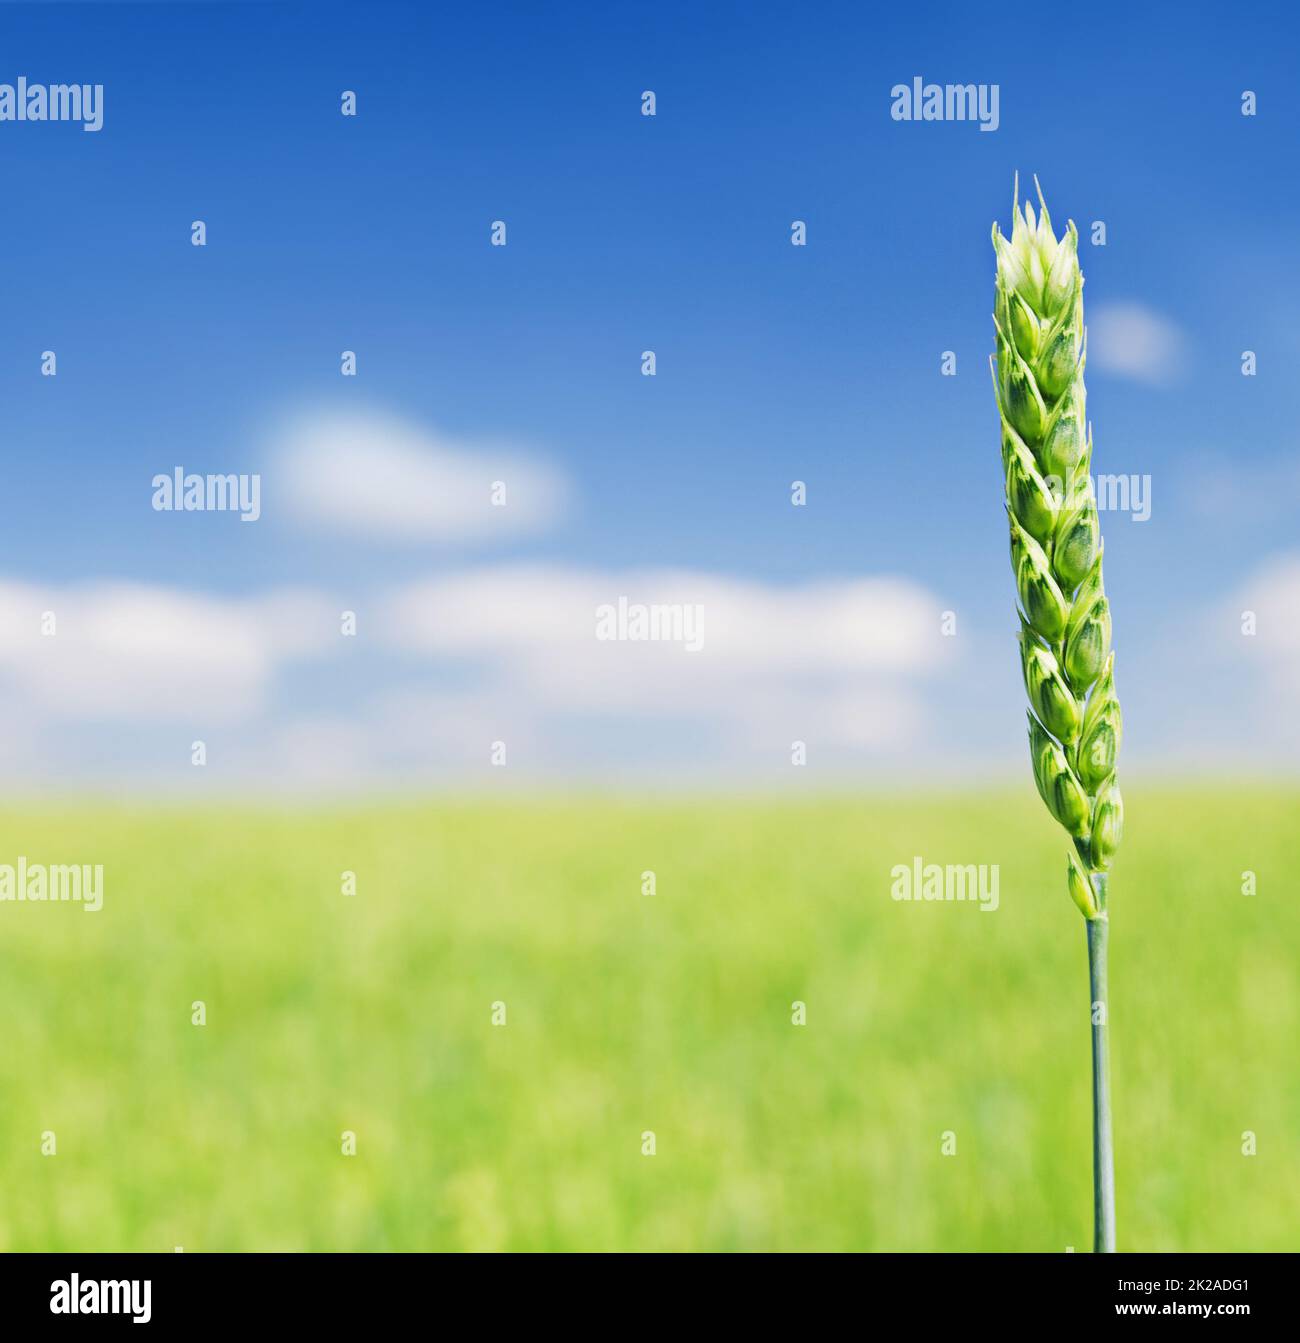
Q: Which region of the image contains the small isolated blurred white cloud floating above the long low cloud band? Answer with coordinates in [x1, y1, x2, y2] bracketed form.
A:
[273, 412, 568, 545]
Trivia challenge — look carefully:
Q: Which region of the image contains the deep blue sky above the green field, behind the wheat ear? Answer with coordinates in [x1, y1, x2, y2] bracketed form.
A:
[0, 4, 1300, 783]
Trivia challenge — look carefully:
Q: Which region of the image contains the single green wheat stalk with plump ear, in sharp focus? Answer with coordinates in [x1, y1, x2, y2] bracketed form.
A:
[992, 177, 1124, 1250]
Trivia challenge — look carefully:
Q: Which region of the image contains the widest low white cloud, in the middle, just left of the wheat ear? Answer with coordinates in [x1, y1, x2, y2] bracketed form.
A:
[380, 565, 954, 749]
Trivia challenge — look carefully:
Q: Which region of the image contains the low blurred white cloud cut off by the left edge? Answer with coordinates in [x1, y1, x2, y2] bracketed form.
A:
[0, 583, 338, 723]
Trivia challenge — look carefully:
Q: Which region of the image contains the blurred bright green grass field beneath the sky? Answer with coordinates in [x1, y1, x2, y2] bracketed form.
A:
[0, 784, 1300, 1252]
